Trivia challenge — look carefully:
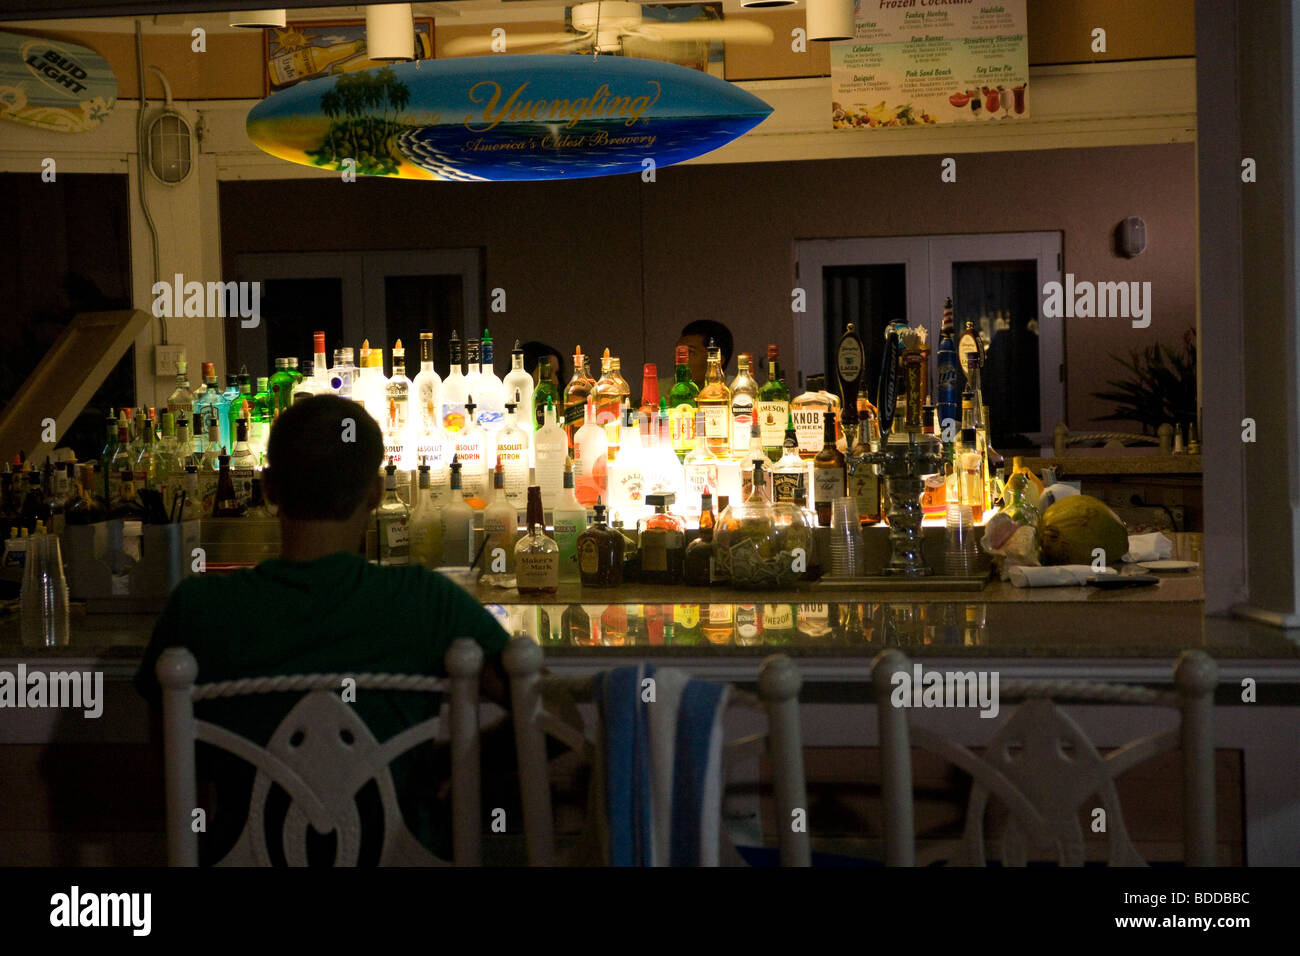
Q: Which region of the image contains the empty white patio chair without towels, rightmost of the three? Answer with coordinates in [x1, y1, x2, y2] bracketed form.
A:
[872, 648, 1218, 866]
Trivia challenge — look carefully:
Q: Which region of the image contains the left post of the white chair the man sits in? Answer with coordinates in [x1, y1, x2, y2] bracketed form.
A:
[155, 648, 199, 866]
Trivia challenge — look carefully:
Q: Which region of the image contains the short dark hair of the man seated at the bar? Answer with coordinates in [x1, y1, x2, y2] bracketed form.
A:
[267, 395, 384, 522]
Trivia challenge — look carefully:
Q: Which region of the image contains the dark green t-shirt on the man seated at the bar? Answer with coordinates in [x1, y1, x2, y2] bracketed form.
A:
[135, 553, 508, 862]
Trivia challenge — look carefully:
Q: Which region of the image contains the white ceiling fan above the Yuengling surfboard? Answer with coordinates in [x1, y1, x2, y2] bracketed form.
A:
[443, 0, 772, 56]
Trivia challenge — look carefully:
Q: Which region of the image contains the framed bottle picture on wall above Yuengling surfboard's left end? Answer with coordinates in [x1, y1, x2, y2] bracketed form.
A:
[263, 17, 433, 96]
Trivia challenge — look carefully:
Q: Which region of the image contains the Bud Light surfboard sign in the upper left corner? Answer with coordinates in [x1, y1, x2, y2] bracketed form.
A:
[0, 33, 117, 133]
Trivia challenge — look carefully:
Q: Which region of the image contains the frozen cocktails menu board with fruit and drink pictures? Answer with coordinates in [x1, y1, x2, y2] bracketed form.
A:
[831, 0, 1030, 129]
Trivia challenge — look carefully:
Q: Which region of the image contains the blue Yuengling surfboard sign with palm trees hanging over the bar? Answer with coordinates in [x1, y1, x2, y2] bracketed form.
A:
[247, 55, 772, 181]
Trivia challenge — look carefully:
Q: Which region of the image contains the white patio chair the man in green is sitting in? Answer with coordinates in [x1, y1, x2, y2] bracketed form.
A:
[157, 637, 484, 866]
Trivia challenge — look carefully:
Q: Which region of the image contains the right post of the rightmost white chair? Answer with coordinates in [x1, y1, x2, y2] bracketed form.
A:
[1174, 650, 1218, 866]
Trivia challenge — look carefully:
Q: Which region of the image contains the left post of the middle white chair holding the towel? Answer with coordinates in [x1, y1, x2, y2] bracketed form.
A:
[502, 635, 555, 866]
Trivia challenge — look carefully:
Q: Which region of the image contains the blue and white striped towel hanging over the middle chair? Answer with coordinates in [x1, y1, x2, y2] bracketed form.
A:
[595, 663, 729, 866]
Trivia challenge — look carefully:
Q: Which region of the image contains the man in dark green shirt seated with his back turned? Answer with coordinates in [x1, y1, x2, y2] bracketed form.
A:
[137, 395, 508, 862]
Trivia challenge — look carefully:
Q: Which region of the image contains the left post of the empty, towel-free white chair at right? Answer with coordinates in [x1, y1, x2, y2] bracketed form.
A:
[871, 648, 917, 866]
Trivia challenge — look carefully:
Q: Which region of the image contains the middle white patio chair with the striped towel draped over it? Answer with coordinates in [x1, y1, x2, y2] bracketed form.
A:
[502, 636, 811, 866]
